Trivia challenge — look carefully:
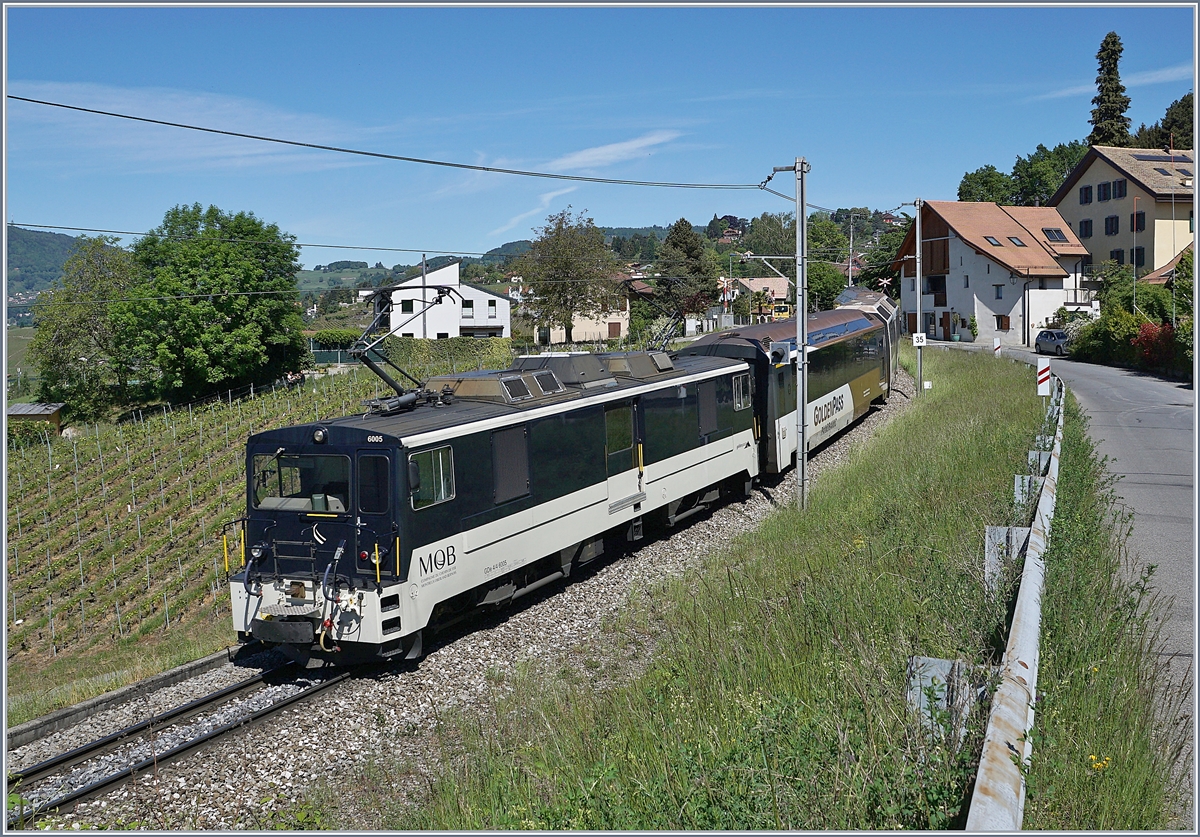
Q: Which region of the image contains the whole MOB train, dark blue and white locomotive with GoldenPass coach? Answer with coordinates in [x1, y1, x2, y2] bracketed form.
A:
[230, 286, 898, 663]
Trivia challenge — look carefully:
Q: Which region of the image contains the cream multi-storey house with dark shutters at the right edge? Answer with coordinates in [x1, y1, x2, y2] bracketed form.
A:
[1049, 145, 1195, 277]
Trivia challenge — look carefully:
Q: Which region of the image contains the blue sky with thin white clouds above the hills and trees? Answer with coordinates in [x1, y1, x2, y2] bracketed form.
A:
[5, 5, 1195, 267]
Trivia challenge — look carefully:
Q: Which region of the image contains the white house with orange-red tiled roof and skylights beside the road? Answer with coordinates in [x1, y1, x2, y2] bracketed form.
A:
[893, 200, 1093, 345]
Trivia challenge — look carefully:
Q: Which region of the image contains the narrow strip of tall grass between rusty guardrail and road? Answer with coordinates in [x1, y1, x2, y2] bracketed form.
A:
[1025, 399, 1192, 831]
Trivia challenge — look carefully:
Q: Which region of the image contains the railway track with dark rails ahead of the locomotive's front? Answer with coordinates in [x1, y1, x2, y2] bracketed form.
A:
[6, 663, 354, 829]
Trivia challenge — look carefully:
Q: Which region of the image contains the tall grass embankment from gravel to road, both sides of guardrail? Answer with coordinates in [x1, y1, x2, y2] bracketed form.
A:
[306, 342, 1166, 830]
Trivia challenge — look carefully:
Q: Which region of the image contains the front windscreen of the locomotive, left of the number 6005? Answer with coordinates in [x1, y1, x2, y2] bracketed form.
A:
[251, 453, 350, 512]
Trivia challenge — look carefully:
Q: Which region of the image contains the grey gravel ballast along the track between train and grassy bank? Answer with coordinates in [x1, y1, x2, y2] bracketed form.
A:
[18, 369, 913, 831]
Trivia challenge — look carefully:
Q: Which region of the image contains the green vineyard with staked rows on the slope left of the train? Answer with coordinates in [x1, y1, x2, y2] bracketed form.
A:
[5, 341, 518, 723]
